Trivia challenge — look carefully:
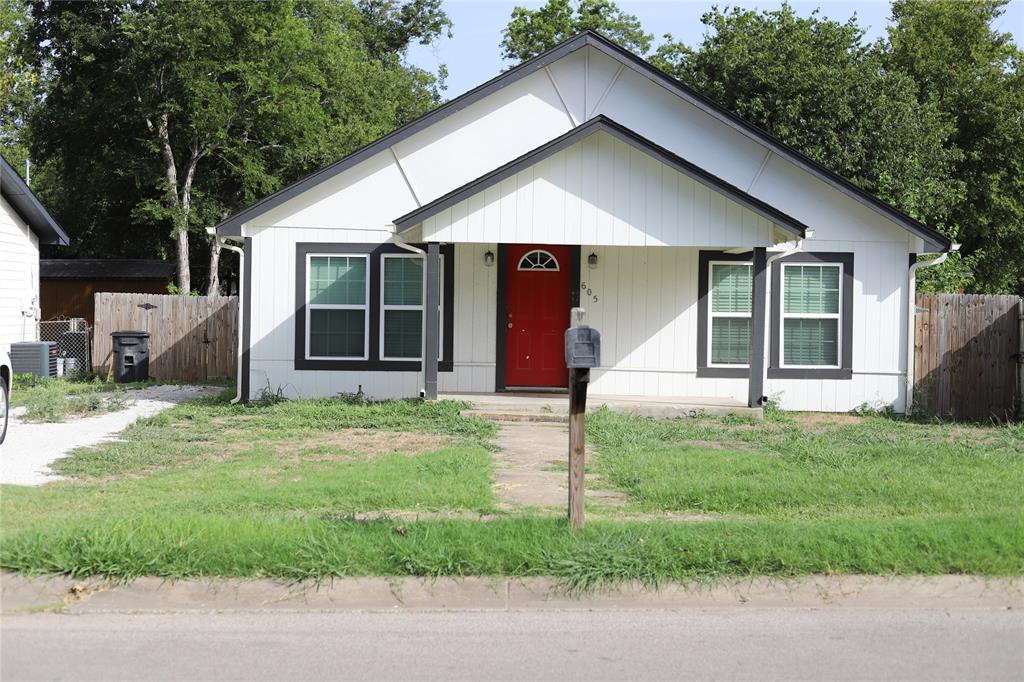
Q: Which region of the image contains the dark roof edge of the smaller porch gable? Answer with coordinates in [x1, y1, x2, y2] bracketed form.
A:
[394, 115, 807, 238]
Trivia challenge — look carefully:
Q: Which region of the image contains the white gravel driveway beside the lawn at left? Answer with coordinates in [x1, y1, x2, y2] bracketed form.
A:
[0, 385, 222, 485]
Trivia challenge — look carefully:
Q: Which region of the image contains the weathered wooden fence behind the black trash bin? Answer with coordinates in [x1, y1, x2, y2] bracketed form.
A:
[92, 293, 239, 381]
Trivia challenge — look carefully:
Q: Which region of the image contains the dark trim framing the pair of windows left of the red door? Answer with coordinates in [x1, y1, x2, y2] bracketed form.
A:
[295, 242, 455, 372]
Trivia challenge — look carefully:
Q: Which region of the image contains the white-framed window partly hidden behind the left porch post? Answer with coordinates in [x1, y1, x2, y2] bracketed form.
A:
[380, 253, 444, 360]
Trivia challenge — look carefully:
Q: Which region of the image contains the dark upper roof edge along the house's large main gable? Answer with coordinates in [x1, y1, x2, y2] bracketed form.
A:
[217, 31, 952, 251]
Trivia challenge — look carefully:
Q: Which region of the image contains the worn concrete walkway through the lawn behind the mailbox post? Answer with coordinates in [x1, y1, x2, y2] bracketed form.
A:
[495, 421, 626, 509]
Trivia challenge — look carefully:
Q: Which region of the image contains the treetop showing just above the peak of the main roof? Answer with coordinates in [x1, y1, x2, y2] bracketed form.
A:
[502, 0, 652, 61]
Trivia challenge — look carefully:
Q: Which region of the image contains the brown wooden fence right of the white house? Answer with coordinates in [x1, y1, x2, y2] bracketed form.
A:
[913, 294, 1022, 420]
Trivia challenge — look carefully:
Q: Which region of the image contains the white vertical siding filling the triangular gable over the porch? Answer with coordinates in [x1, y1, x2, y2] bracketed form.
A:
[422, 132, 775, 247]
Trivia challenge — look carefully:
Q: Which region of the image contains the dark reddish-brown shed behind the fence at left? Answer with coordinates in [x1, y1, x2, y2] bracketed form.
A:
[39, 258, 174, 327]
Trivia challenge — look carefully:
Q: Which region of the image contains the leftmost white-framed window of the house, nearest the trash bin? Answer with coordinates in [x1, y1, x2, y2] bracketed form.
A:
[306, 254, 370, 359]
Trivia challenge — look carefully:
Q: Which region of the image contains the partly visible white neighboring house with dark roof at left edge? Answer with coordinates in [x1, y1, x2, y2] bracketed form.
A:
[0, 157, 68, 343]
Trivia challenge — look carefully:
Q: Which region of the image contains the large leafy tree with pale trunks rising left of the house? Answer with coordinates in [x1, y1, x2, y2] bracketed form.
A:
[29, 0, 446, 293]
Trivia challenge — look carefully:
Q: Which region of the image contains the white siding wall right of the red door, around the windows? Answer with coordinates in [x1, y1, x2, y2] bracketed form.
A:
[581, 242, 906, 411]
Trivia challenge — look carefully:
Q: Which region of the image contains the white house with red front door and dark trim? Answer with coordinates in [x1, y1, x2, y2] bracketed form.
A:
[216, 33, 954, 411]
